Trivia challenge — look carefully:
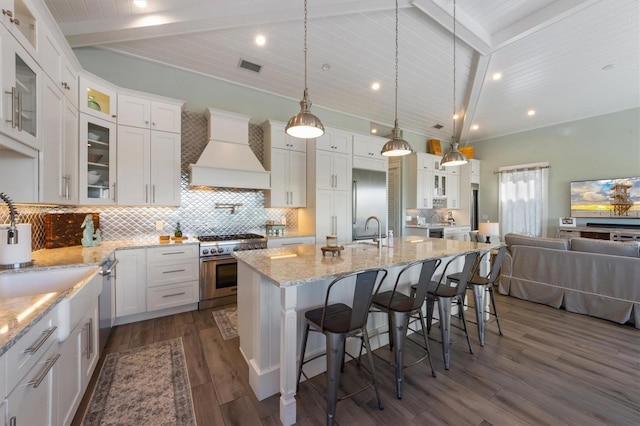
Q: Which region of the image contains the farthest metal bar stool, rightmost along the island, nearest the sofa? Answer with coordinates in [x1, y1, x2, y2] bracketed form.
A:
[447, 246, 507, 346]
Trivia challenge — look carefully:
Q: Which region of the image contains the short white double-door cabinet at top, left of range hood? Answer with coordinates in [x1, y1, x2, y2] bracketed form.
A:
[118, 93, 182, 133]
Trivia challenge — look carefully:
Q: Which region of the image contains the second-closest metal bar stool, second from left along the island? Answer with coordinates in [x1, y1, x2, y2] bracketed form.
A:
[371, 259, 441, 399]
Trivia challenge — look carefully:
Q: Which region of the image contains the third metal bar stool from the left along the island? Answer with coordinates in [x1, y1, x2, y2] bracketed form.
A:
[411, 252, 478, 370]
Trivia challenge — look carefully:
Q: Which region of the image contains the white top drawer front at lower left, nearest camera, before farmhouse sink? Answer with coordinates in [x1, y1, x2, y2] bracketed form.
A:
[5, 309, 58, 393]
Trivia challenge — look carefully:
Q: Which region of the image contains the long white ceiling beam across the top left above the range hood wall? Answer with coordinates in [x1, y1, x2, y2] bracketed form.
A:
[59, 0, 411, 47]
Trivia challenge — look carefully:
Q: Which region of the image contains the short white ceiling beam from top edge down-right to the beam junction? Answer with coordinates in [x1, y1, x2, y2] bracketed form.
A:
[411, 0, 492, 55]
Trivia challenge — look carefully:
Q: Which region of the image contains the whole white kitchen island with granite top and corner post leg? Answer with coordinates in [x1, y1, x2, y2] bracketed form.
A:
[234, 237, 490, 425]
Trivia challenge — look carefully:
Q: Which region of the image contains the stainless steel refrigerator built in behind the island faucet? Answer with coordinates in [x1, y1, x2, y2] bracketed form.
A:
[351, 169, 387, 240]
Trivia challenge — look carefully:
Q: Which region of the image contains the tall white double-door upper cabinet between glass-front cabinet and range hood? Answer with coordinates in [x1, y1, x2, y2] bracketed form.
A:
[116, 126, 180, 206]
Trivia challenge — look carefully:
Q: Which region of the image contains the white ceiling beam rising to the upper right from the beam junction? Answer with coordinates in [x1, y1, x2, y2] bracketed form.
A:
[493, 0, 601, 51]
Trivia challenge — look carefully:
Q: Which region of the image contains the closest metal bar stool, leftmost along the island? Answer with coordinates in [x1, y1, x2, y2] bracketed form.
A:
[296, 269, 387, 425]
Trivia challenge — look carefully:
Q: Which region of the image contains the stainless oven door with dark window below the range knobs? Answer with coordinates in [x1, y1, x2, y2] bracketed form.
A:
[200, 256, 238, 301]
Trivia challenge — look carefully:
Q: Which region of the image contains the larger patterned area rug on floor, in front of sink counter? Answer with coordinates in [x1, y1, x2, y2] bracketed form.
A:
[82, 338, 196, 426]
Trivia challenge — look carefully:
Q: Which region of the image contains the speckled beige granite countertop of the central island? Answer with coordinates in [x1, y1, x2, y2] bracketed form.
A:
[233, 237, 492, 287]
